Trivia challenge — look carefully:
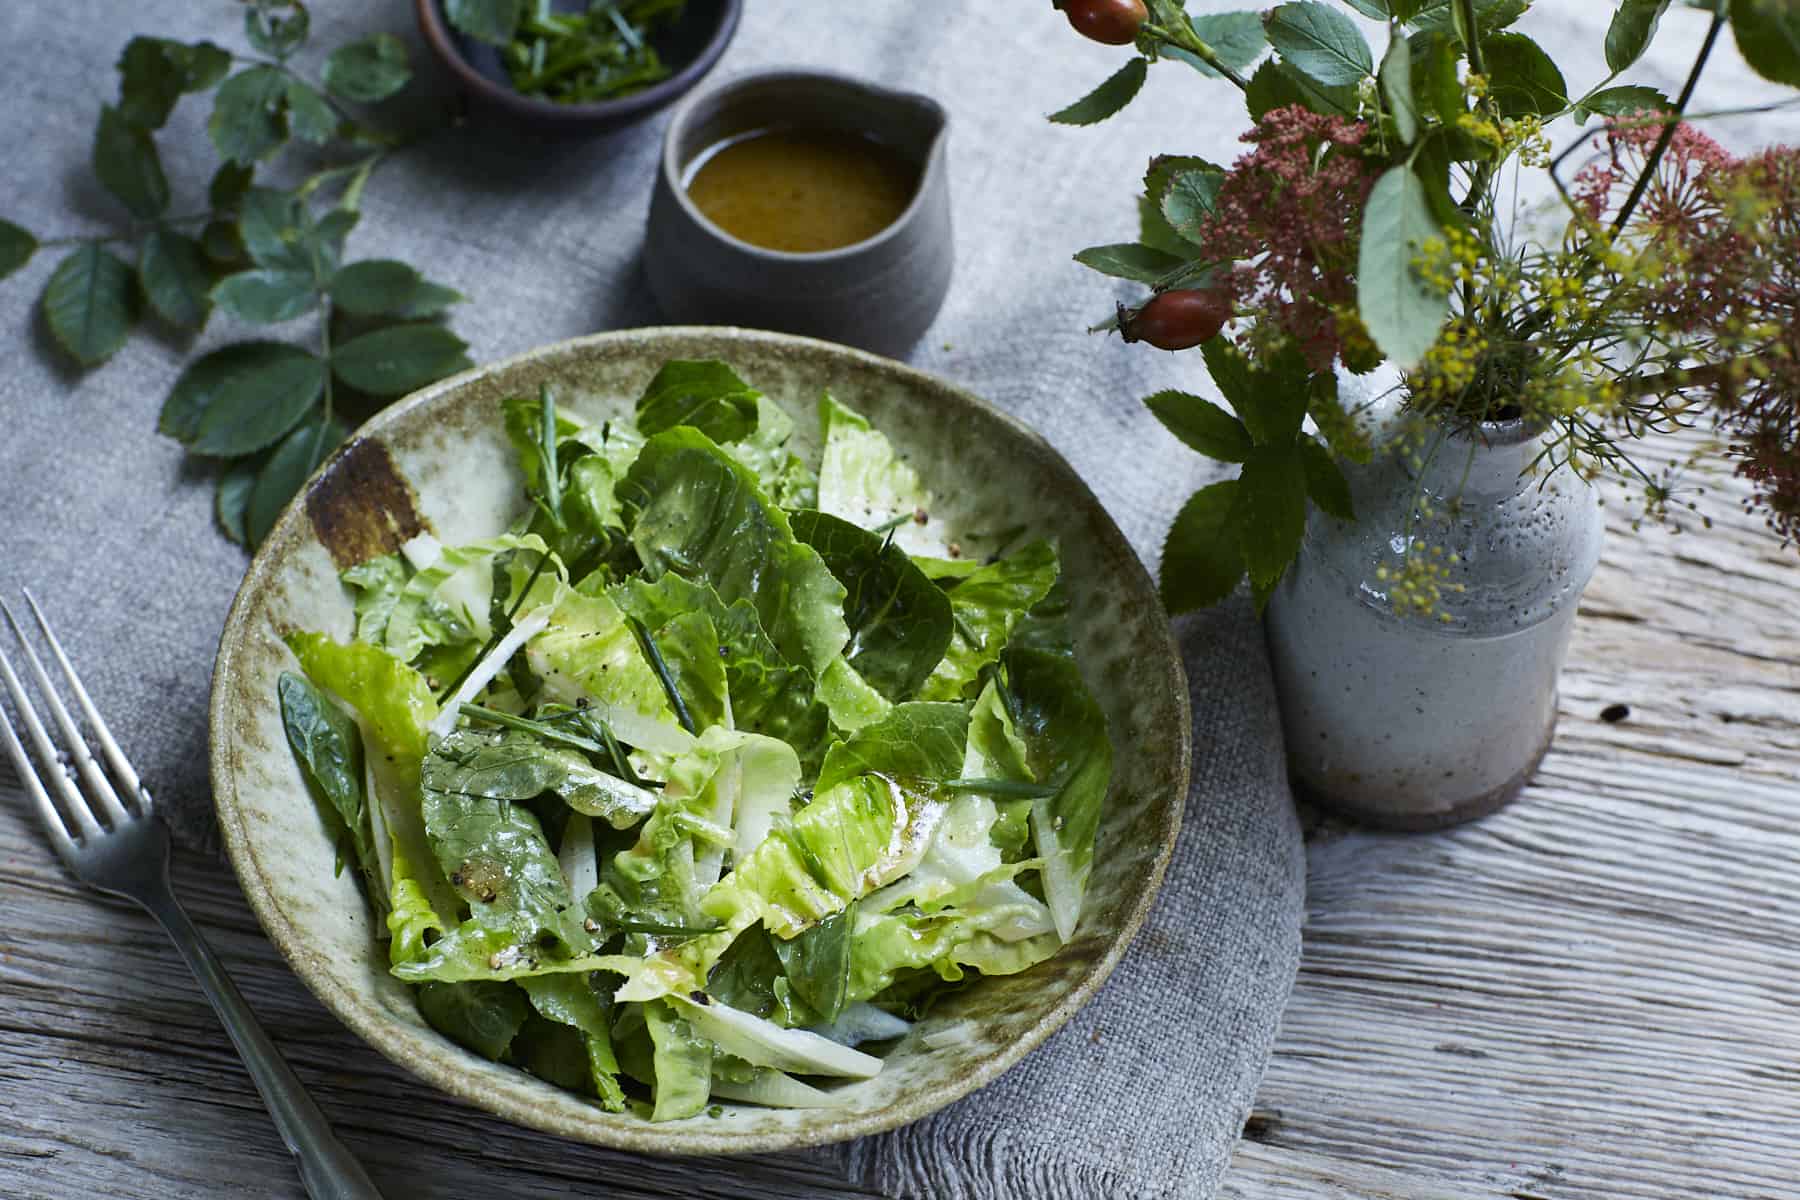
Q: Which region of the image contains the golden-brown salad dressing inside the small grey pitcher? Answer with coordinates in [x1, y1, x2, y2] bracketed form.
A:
[686, 128, 920, 254]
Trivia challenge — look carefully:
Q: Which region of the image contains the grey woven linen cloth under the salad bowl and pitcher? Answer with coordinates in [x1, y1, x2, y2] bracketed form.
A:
[0, 0, 1303, 1200]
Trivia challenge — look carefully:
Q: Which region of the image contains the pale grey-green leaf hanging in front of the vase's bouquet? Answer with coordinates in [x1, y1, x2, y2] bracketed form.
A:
[1357, 167, 1447, 369]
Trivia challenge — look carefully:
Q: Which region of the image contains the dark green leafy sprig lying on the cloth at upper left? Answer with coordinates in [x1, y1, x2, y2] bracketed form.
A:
[0, 0, 470, 547]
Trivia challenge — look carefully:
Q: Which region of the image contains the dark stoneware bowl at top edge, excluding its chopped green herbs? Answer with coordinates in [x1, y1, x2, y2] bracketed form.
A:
[414, 0, 743, 135]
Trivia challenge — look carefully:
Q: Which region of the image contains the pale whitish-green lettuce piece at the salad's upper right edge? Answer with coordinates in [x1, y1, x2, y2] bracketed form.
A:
[819, 394, 945, 554]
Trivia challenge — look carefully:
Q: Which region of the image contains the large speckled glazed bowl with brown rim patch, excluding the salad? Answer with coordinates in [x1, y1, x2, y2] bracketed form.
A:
[211, 327, 1190, 1153]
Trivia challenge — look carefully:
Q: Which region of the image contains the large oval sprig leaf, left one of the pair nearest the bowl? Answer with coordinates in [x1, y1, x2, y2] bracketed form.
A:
[180, 342, 326, 459]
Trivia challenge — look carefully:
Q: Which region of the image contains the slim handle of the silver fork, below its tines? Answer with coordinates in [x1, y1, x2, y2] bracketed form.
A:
[140, 885, 382, 1200]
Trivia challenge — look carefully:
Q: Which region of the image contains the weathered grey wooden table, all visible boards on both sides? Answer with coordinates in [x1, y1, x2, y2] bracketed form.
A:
[0, 426, 1800, 1200]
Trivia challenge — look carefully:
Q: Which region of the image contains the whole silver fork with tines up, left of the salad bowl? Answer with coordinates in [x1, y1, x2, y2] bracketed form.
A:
[0, 592, 382, 1200]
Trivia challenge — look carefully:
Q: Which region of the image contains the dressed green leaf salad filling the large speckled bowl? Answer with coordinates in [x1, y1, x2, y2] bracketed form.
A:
[279, 362, 1112, 1121]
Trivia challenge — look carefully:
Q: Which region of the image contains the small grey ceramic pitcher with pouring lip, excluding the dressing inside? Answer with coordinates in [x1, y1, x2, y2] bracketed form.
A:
[644, 70, 954, 354]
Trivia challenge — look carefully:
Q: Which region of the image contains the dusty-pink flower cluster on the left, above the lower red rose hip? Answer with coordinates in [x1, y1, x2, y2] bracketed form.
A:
[1199, 104, 1375, 371]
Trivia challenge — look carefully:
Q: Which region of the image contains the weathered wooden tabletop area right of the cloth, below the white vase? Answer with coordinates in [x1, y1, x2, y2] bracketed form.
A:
[1224, 424, 1800, 1200]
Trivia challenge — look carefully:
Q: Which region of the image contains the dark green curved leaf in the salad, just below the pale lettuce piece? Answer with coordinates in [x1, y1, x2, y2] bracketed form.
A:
[790, 511, 952, 702]
